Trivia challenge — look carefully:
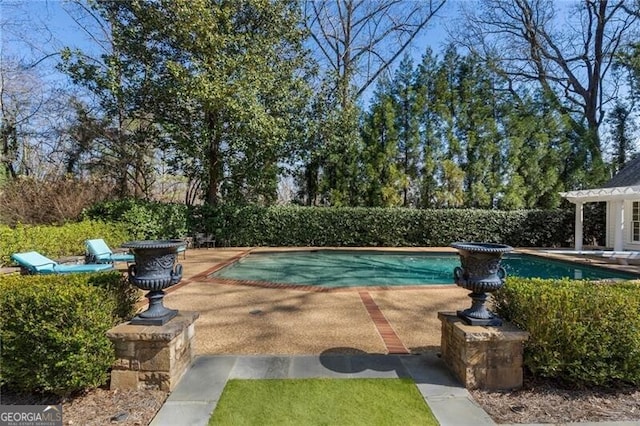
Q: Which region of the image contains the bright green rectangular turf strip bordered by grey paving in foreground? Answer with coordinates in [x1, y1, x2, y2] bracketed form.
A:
[209, 379, 438, 426]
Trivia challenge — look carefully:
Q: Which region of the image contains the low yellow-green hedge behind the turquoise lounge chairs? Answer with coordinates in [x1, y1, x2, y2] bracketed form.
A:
[0, 220, 131, 265]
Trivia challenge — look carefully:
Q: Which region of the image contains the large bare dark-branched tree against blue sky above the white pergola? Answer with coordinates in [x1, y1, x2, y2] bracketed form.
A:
[458, 0, 638, 179]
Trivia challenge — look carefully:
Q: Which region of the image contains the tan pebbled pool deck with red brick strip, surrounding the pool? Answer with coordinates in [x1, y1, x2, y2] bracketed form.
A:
[165, 247, 640, 355]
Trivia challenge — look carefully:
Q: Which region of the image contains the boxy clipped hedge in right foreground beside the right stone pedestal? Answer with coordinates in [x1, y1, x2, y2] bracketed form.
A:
[494, 278, 640, 385]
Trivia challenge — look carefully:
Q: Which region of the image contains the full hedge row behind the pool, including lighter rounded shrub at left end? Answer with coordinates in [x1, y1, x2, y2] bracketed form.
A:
[86, 200, 589, 247]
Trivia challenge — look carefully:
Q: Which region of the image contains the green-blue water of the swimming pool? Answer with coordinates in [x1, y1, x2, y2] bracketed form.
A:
[211, 250, 635, 287]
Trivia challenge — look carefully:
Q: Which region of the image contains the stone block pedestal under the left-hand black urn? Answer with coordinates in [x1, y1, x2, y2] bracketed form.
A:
[107, 311, 200, 391]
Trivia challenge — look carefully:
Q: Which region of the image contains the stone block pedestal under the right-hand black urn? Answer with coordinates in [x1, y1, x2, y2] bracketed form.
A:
[438, 312, 529, 390]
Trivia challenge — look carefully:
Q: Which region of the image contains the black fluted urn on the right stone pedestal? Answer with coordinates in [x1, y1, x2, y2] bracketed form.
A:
[451, 242, 513, 326]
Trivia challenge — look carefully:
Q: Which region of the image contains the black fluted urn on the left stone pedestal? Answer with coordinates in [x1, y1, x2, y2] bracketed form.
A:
[122, 240, 185, 325]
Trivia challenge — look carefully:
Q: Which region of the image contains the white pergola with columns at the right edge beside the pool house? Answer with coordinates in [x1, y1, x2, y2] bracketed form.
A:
[560, 185, 640, 251]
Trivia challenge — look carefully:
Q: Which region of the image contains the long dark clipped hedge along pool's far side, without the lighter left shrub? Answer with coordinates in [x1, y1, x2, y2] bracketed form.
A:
[202, 206, 573, 247]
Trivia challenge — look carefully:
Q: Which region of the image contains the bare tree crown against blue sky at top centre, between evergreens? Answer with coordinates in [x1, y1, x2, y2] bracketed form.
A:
[304, 0, 446, 107]
